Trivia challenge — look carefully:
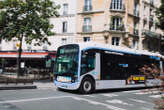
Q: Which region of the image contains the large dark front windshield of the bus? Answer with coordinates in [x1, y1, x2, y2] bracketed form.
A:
[54, 45, 79, 76]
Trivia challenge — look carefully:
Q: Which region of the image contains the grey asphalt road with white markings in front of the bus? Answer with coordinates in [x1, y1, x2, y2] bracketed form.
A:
[0, 88, 160, 110]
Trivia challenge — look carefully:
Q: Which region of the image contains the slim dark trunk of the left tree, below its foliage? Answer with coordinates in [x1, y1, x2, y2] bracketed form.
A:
[17, 35, 23, 76]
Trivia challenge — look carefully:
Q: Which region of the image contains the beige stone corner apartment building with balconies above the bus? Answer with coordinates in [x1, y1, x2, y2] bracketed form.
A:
[77, 0, 162, 52]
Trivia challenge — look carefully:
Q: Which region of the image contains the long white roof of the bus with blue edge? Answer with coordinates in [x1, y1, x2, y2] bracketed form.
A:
[72, 42, 164, 58]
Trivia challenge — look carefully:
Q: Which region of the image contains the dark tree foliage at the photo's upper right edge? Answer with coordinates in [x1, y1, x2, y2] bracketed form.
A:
[156, 0, 164, 31]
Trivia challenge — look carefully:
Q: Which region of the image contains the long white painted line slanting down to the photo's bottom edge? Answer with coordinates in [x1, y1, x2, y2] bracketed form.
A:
[72, 96, 126, 110]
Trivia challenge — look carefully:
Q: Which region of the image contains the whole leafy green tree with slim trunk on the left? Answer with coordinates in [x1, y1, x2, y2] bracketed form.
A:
[0, 0, 60, 75]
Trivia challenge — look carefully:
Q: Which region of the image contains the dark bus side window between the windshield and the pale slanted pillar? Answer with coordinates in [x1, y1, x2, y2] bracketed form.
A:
[81, 51, 95, 75]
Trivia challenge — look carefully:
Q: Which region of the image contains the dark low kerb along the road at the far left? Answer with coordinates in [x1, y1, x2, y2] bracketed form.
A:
[0, 85, 37, 90]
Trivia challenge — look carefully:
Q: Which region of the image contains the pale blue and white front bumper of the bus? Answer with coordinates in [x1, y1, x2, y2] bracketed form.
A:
[54, 80, 79, 90]
